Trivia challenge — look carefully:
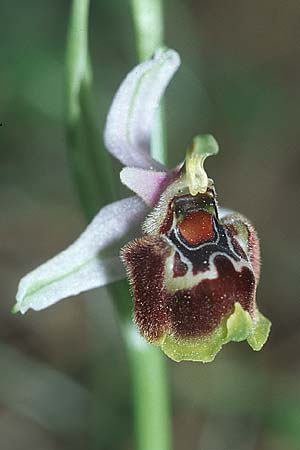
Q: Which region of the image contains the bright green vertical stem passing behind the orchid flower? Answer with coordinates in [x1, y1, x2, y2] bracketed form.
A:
[127, 0, 171, 450]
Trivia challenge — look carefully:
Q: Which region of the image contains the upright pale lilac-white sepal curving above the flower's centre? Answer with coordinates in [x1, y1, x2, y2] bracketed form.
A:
[104, 50, 180, 169]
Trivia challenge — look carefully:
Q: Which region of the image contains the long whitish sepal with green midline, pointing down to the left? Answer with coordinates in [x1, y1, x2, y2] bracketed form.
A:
[14, 197, 146, 313]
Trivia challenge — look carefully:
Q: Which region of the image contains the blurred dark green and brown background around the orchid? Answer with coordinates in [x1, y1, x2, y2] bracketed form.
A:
[0, 0, 300, 450]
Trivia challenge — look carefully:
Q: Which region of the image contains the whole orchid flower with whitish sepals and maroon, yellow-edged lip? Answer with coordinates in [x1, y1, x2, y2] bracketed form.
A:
[14, 50, 270, 362]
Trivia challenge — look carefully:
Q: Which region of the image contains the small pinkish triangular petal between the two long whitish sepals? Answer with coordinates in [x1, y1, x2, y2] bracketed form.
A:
[120, 167, 173, 206]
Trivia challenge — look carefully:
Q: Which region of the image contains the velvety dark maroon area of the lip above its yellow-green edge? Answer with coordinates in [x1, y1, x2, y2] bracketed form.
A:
[123, 236, 256, 342]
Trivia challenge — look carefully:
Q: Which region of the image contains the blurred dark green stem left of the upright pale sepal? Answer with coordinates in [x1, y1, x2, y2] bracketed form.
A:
[65, 0, 114, 220]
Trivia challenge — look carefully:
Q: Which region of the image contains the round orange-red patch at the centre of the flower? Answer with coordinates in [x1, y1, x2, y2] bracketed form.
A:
[178, 211, 214, 245]
